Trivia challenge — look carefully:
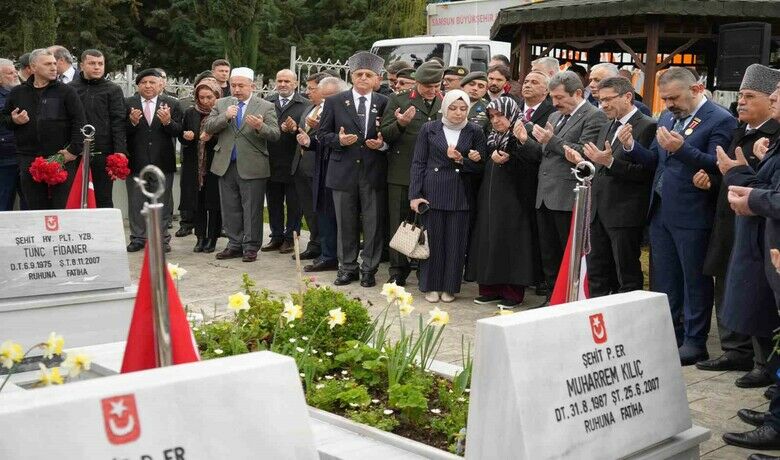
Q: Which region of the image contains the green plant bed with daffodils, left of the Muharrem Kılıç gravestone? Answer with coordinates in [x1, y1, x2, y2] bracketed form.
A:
[193, 274, 472, 454]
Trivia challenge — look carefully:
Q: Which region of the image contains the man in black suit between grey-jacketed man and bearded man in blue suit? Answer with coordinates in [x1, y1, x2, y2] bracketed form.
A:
[564, 77, 656, 297]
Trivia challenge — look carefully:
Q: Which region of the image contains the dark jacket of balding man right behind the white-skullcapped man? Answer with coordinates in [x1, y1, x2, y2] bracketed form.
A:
[265, 93, 311, 183]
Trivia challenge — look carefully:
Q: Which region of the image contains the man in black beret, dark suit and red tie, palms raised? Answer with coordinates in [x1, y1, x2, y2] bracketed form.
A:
[125, 69, 182, 252]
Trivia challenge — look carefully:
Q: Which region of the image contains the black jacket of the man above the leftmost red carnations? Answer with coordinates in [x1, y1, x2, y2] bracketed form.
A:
[0, 77, 85, 157]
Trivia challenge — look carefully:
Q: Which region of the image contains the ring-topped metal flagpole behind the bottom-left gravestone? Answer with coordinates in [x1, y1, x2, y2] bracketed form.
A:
[135, 165, 173, 367]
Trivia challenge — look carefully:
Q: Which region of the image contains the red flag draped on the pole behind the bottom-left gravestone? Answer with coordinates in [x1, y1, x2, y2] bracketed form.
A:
[122, 248, 200, 374]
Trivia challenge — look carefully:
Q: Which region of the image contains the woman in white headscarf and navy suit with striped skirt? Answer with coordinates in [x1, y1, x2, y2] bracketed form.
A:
[409, 90, 485, 302]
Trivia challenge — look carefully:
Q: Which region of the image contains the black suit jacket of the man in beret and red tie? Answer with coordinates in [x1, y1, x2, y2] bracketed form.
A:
[125, 93, 182, 175]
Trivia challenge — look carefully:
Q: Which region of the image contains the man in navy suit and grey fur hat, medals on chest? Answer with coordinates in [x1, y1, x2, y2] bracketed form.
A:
[320, 51, 387, 287]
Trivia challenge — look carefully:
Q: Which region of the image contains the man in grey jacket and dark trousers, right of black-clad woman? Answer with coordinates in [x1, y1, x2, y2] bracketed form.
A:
[527, 71, 607, 300]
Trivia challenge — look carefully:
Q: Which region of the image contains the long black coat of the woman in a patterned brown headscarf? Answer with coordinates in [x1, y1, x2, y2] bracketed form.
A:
[179, 107, 219, 211]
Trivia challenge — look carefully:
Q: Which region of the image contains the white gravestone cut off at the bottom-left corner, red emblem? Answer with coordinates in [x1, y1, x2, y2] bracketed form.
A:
[0, 352, 318, 460]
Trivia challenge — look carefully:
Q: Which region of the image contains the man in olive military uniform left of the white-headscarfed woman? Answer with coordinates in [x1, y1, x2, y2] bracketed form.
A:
[381, 61, 444, 286]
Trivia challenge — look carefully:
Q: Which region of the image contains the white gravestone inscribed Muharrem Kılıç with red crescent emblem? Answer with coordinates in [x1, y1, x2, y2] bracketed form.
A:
[466, 291, 697, 460]
